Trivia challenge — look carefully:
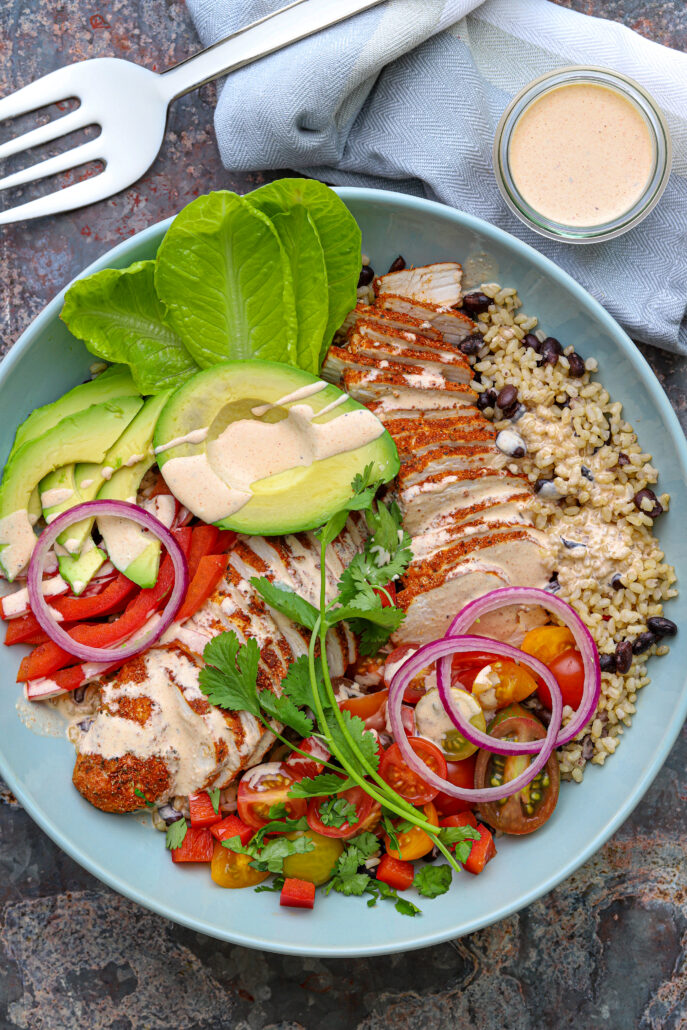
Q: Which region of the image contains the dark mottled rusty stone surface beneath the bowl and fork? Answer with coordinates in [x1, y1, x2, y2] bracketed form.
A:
[0, 0, 687, 1030]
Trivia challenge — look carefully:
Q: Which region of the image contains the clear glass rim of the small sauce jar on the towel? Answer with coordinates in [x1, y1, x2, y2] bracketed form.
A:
[492, 65, 673, 243]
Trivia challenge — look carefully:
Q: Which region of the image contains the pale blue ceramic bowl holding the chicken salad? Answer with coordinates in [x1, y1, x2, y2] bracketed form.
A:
[0, 188, 687, 956]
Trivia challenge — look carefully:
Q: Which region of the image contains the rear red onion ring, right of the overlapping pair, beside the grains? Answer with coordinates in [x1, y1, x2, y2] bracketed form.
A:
[437, 586, 602, 748]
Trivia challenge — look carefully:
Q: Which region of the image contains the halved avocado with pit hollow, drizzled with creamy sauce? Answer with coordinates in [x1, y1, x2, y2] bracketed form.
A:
[153, 359, 399, 536]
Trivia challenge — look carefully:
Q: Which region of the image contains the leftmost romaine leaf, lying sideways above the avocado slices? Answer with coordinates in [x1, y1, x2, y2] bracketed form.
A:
[60, 261, 198, 393]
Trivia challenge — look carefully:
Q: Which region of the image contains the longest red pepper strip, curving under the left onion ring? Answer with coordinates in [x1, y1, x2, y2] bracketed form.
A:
[16, 528, 191, 683]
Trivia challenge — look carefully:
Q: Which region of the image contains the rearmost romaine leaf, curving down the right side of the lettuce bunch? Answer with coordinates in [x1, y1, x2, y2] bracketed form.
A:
[246, 179, 362, 364]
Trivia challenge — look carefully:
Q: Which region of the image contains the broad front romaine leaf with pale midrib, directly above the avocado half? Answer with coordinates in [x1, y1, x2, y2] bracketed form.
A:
[156, 191, 298, 368]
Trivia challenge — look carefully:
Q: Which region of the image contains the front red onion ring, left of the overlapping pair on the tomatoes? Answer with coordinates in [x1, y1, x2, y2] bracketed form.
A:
[387, 636, 562, 803]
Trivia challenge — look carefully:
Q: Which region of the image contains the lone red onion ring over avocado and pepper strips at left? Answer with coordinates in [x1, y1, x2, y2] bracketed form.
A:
[27, 501, 188, 662]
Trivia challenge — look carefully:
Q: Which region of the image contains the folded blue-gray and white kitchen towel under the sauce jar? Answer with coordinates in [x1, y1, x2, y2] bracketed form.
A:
[187, 0, 687, 354]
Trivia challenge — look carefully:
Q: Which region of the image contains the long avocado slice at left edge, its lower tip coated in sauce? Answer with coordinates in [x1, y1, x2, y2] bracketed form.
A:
[0, 397, 143, 582]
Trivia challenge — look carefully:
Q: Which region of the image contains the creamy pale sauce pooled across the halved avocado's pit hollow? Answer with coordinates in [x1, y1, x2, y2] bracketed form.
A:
[163, 397, 384, 522]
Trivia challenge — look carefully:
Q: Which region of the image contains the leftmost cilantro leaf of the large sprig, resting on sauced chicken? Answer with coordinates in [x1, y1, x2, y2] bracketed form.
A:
[199, 630, 260, 716]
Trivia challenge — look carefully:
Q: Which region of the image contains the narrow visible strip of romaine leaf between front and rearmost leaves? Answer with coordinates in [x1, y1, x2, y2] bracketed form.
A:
[272, 205, 330, 375]
